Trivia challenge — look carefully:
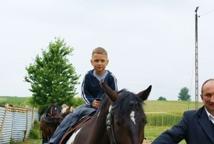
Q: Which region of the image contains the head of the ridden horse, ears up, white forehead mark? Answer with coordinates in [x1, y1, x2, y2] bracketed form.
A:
[102, 83, 152, 144]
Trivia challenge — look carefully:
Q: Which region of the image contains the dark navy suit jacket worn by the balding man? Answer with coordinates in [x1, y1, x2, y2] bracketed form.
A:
[152, 107, 214, 144]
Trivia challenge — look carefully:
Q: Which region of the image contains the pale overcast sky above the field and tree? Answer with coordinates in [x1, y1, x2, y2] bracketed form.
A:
[0, 0, 214, 100]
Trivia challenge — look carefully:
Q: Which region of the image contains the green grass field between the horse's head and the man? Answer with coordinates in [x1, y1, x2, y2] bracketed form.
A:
[144, 101, 202, 144]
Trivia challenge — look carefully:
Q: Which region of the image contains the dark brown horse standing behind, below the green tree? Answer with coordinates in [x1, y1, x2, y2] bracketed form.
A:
[40, 104, 63, 143]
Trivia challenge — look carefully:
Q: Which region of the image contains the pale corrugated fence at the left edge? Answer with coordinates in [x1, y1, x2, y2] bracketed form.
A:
[0, 106, 39, 144]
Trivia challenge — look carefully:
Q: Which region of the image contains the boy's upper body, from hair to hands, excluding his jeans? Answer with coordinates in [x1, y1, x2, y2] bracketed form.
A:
[82, 47, 117, 109]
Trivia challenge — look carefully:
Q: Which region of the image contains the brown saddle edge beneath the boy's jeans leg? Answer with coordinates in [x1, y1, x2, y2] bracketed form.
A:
[60, 115, 93, 144]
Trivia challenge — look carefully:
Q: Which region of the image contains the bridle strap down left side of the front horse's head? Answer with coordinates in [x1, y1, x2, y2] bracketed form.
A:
[106, 105, 118, 144]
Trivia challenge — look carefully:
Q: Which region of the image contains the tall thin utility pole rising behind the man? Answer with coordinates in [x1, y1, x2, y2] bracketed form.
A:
[195, 7, 199, 109]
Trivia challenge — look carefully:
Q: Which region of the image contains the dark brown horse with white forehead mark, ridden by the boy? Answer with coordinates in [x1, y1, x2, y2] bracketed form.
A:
[61, 83, 152, 144]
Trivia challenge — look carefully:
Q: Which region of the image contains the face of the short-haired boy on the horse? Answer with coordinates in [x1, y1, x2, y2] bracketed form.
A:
[91, 53, 108, 74]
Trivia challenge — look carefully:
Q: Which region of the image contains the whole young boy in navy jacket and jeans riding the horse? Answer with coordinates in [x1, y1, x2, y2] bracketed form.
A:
[49, 47, 117, 144]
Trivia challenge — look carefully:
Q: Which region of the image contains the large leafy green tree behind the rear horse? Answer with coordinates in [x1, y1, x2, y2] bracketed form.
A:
[25, 38, 79, 113]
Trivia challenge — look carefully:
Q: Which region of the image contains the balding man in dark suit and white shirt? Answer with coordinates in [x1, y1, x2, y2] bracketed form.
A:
[152, 79, 214, 144]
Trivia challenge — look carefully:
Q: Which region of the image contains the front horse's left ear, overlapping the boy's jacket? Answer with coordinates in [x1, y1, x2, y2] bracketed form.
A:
[100, 81, 117, 102]
